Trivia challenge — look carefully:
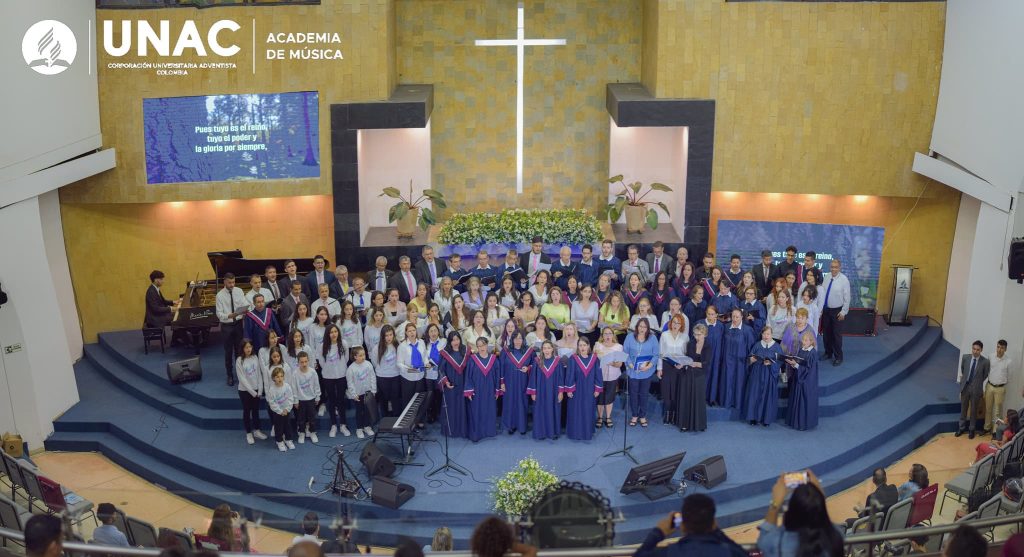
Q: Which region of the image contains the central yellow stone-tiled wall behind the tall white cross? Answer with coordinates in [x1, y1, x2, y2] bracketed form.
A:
[397, 0, 642, 212]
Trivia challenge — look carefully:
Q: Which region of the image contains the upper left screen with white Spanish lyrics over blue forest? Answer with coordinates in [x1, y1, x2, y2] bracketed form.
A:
[142, 91, 319, 184]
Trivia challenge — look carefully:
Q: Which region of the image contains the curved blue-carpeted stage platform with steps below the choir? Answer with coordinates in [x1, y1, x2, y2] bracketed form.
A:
[46, 317, 959, 549]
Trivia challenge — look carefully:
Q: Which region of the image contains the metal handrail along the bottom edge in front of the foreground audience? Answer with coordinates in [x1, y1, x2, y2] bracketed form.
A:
[0, 513, 1024, 557]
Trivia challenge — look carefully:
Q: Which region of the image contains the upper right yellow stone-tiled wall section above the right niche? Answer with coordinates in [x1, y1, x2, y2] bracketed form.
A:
[643, 0, 945, 196]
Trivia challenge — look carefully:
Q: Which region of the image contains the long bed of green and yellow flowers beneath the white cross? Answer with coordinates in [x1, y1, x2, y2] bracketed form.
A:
[437, 209, 603, 246]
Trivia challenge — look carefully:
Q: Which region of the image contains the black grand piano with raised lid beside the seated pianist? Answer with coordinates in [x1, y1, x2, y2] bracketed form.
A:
[171, 250, 313, 354]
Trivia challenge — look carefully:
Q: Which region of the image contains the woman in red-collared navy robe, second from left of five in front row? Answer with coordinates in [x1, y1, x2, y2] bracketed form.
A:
[463, 337, 502, 442]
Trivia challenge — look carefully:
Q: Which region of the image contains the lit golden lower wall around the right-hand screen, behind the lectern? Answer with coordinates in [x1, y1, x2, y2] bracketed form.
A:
[708, 186, 959, 323]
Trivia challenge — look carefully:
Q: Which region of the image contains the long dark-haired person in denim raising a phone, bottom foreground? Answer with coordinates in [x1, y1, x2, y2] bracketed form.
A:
[758, 470, 843, 557]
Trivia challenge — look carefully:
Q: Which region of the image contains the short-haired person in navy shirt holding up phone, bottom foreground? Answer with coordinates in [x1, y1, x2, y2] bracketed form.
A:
[633, 494, 746, 557]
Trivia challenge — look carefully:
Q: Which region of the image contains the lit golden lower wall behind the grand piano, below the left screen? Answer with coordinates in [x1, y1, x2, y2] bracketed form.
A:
[60, 196, 334, 342]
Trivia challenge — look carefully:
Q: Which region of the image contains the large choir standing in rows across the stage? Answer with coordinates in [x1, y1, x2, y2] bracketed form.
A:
[184, 239, 838, 451]
